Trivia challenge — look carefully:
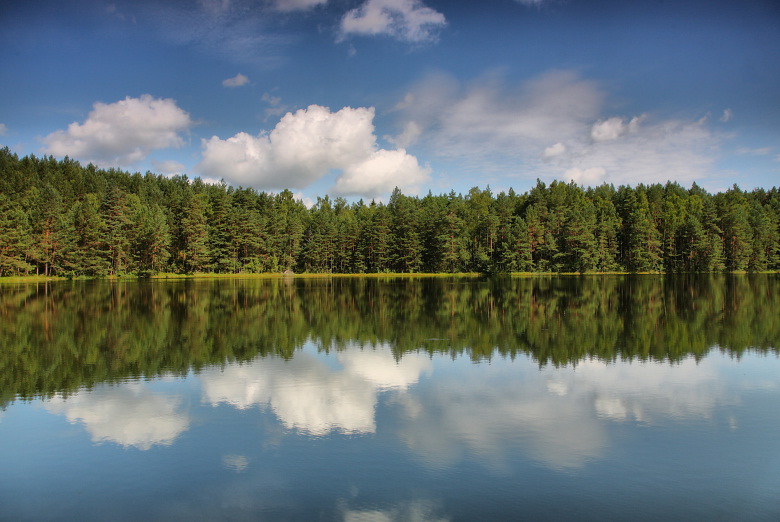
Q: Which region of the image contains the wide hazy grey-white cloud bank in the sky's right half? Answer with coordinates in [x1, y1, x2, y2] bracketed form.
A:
[395, 70, 724, 184]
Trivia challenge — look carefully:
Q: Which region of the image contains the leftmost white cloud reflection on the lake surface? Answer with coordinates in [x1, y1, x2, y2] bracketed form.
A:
[45, 383, 189, 450]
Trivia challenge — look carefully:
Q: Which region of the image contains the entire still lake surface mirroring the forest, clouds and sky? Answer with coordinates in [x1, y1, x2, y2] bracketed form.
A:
[0, 275, 780, 521]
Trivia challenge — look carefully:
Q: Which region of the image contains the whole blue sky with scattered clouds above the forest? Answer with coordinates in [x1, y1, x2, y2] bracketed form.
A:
[0, 0, 780, 202]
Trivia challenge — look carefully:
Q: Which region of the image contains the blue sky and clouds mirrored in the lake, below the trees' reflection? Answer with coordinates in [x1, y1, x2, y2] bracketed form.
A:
[0, 341, 780, 520]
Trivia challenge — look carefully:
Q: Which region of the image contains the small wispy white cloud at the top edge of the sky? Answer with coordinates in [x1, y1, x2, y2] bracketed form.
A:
[340, 0, 447, 42]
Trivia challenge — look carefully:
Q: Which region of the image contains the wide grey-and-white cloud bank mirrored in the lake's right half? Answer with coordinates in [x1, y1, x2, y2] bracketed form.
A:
[395, 355, 741, 469]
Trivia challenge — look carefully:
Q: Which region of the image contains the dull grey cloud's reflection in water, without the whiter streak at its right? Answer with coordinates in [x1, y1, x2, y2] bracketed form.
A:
[398, 361, 609, 469]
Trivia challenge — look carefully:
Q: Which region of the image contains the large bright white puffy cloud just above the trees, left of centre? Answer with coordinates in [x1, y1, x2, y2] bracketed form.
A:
[196, 105, 428, 196]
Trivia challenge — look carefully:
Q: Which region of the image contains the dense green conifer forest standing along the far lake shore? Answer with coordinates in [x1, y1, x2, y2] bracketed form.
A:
[0, 147, 780, 276]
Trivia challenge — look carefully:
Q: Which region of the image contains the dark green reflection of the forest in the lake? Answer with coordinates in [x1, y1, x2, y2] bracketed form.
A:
[0, 274, 780, 408]
